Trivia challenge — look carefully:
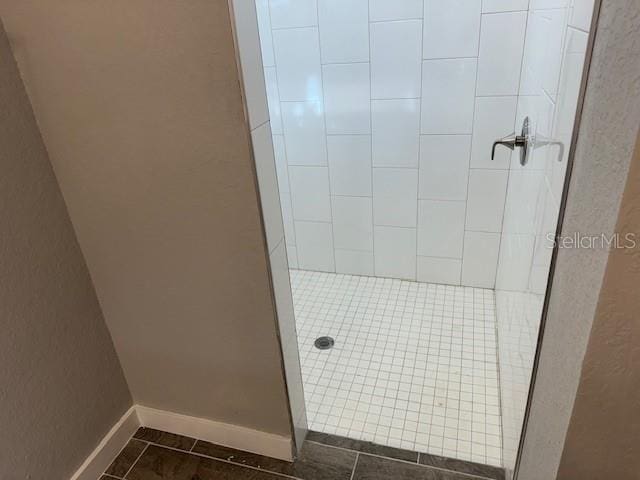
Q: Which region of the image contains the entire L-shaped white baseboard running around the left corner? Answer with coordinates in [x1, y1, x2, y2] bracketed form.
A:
[70, 405, 293, 480]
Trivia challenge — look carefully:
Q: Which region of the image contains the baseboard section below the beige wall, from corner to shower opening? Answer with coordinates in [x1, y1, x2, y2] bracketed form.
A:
[136, 405, 293, 461]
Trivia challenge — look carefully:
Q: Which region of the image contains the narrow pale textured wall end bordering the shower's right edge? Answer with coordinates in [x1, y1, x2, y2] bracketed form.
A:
[518, 0, 640, 480]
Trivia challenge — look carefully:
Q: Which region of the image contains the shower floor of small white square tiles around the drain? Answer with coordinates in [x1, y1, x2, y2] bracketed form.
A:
[291, 270, 502, 466]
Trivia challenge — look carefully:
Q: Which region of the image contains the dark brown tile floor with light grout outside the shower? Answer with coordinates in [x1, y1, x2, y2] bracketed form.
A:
[100, 428, 504, 480]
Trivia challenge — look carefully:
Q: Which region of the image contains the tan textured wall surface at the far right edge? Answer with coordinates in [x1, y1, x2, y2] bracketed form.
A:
[558, 129, 640, 480]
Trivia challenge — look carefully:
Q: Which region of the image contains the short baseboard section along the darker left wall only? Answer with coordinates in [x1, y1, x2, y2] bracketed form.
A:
[71, 405, 140, 480]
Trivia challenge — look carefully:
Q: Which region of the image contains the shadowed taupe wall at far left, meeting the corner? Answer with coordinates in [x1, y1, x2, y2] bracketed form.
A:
[0, 20, 131, 480]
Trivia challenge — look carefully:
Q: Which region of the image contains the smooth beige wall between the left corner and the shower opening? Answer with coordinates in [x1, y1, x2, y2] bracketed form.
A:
[0, 0, 291, 436]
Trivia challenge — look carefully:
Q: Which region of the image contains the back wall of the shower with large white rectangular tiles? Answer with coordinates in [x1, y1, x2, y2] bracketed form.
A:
[257, 0, 536, 288]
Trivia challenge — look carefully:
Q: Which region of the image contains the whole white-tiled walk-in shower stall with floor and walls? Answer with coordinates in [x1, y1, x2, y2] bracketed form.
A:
[236, 0, 594, 470]
